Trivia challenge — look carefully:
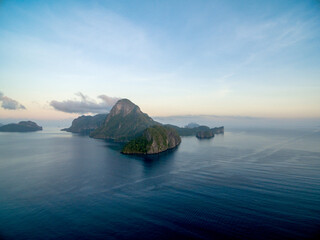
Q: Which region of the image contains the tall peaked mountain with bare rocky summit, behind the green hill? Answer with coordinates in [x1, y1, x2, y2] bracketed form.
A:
[90, 99, 159, 142]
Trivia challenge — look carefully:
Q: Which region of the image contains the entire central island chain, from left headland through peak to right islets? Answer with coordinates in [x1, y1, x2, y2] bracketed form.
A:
[62, 99, 224, 154]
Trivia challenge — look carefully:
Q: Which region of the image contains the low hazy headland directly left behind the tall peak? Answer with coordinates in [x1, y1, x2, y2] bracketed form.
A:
[62, 114, 108, 134]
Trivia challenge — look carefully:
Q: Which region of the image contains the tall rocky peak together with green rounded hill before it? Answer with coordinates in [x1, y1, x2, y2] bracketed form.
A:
[90, 99, 181, 154]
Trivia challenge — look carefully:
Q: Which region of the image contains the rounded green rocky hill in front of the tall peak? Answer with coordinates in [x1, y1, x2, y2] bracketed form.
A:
[122, 125, 181, 154]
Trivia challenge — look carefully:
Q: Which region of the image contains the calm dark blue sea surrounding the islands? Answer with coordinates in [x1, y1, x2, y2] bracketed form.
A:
[0, 126, 320, 239]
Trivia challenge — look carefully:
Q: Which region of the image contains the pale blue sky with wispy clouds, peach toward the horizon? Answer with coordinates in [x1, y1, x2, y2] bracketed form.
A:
[0, 0, 320, 124]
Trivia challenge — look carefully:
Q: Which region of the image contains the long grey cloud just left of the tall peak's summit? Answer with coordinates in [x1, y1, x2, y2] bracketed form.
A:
[50, 92, 119, 114]
